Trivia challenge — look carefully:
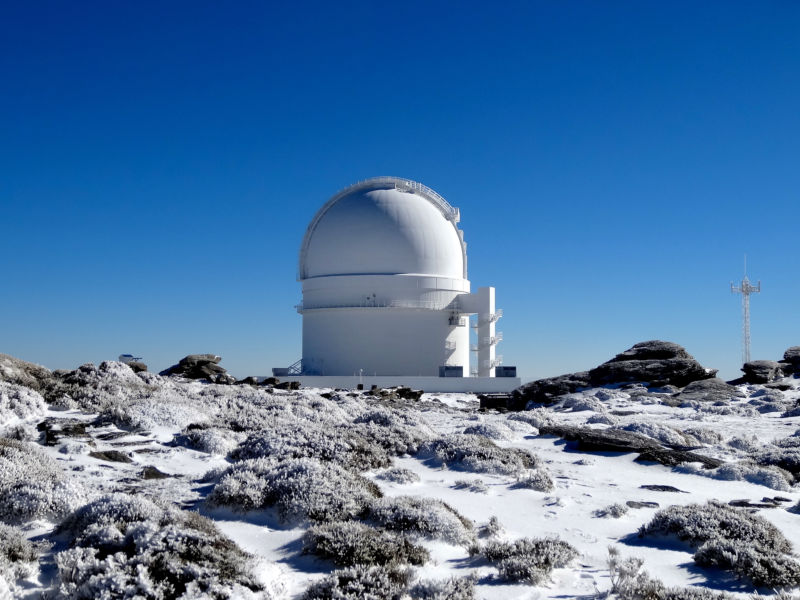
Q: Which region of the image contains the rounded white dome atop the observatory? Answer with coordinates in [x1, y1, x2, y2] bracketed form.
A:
[299, 177, 467, 280]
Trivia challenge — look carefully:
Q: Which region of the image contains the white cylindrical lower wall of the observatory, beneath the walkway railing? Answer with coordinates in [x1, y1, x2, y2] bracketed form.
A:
[303, 307, 469, 377]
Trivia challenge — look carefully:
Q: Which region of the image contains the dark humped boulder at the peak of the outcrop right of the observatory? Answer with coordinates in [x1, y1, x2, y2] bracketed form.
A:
[589, 340, 717, 387]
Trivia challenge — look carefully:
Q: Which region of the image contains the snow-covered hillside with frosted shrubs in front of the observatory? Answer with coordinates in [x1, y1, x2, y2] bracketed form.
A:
[0, 363, 800, 599]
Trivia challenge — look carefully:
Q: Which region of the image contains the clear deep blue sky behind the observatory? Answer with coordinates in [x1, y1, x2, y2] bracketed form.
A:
[0, 0, 800, 379]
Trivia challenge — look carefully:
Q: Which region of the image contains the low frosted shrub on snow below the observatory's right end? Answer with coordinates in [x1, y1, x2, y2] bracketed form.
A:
[420, 433, 538, 475]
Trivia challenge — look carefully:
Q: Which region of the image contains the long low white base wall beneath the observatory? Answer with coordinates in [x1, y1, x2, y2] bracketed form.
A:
[280, 375, 520, 394]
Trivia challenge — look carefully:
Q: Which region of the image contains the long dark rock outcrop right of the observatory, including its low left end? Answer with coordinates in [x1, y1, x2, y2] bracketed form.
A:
[514, 340, 717, 404]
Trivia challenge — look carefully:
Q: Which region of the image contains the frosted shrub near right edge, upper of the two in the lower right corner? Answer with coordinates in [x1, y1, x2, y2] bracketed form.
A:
[639, 501, 792, 552]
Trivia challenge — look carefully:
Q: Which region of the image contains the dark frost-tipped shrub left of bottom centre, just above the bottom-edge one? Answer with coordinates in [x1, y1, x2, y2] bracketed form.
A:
[303, 521, 430, 567]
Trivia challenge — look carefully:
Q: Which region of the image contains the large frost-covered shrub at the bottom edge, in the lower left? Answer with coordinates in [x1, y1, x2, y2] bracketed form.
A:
[56, 494, 262, 600]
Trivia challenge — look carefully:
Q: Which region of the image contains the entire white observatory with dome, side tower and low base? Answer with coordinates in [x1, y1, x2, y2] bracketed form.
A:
[273, 177, 520, 392]
